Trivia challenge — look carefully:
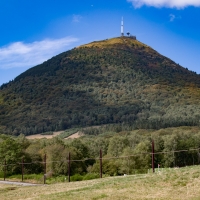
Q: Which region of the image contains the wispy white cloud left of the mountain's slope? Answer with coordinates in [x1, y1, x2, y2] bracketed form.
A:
[0, 37, 78, 69]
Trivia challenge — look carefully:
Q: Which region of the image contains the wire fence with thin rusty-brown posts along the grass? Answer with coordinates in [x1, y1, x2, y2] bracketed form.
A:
[1, 141, 200, 184]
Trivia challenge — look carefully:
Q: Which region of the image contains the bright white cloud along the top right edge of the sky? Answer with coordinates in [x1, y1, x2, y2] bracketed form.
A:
[127, 0, 200, 9]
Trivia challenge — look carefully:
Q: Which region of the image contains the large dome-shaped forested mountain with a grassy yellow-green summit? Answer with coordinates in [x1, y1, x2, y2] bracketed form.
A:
[0, 37, 200, 135]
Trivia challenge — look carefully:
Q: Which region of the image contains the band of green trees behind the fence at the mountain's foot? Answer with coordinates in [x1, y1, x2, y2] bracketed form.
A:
[0, 125, 200, 177]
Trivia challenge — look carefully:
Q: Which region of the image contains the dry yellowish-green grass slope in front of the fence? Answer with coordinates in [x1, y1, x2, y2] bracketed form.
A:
[0, 166, 200, 200]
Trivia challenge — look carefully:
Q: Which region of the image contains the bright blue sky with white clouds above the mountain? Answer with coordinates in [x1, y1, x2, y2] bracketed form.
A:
[0, 0, 200, 85]
